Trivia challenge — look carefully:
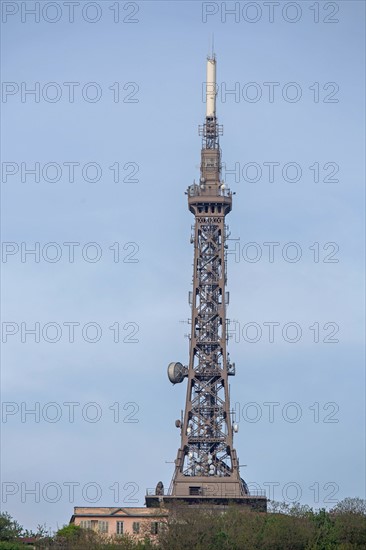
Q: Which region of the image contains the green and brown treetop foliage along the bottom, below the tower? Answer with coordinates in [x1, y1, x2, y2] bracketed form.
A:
[0, 498, 366, 550]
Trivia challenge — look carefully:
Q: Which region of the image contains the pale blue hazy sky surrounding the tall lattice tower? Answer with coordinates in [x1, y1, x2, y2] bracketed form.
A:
[1, 1, 365, 528]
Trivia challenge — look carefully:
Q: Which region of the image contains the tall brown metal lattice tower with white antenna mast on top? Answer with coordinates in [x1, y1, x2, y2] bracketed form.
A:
[146, 56, 266, 510]
